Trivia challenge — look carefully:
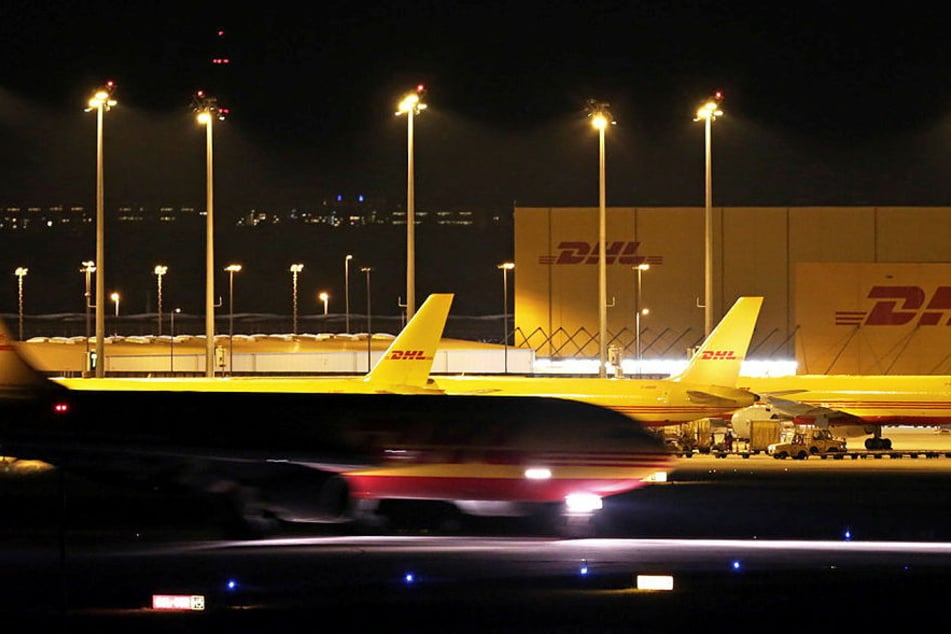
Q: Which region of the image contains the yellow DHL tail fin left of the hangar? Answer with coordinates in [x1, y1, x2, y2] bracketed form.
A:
[363, 293, 454, 390]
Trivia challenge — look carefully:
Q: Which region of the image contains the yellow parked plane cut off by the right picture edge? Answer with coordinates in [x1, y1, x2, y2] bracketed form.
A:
[733, 375, 951, 449]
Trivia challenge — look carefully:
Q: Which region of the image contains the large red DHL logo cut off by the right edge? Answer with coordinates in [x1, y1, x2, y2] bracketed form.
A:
[835, 286, 951, 326]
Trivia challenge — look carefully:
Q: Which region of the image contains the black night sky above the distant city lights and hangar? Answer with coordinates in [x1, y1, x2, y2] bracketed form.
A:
[0, 0, 951, 310]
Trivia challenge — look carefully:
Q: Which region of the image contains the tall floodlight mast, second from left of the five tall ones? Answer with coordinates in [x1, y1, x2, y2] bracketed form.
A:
[193, 90, 226, 377]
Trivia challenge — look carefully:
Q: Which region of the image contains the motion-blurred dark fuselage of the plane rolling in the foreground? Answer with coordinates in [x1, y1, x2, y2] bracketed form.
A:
[0, 389, 673, 503]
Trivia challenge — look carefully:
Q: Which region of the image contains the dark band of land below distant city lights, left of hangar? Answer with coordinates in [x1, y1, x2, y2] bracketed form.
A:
[0, 216, 514, 316]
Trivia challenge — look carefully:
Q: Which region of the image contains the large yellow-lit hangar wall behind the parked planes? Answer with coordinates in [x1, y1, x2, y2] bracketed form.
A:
[513, 207, 951, 374]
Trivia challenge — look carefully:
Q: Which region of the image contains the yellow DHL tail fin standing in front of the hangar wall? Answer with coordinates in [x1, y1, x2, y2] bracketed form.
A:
[672, 297, 763, 387]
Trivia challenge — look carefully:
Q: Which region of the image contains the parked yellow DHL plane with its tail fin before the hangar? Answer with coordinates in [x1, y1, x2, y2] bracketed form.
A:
[432, 297, 763, 427]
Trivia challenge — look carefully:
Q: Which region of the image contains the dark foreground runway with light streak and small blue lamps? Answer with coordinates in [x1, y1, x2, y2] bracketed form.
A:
[0, 428, 951, 632]
